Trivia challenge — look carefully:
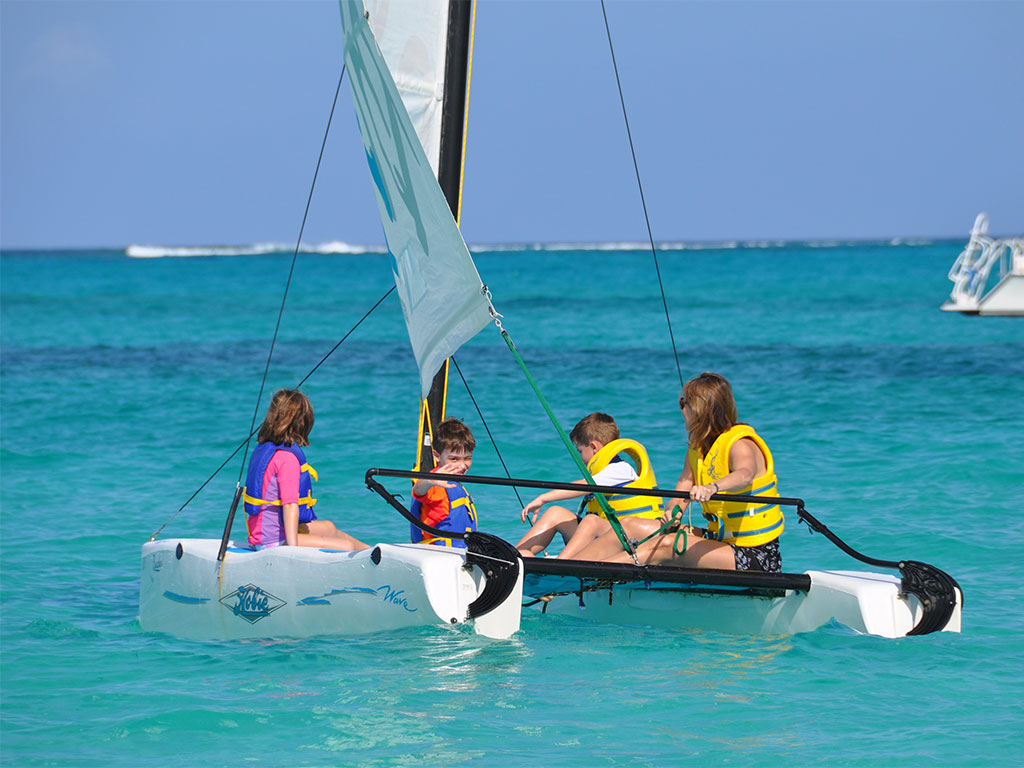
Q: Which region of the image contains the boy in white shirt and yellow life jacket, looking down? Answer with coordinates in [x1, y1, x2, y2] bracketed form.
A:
[516, 412, 662, 559]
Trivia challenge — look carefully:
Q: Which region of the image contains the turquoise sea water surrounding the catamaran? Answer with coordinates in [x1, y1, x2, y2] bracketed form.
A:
[0, 243, 1024, 766]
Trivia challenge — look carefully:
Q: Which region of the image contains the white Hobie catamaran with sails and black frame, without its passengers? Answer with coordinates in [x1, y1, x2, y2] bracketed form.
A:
[139, 0, 963, 639]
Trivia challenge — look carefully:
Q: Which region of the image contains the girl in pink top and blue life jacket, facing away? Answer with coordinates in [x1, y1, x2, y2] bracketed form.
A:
[242, 389, 367, 550]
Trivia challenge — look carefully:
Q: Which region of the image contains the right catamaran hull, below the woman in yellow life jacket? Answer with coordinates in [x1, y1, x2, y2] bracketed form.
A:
[526, 570, 963, 638]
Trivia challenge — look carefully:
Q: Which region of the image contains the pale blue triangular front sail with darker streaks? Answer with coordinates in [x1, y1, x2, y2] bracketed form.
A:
[341, 0, 490, 396]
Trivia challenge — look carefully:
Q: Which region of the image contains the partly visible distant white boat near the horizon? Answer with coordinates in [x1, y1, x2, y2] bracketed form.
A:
[942, 213, 1024, 315]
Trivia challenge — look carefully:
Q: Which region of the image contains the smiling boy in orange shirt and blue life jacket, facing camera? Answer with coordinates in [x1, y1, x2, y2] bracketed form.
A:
[410, 419, 476, 549]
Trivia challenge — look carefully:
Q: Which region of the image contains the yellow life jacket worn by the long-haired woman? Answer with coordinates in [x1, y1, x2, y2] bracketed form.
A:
[686, 424, 785, 547]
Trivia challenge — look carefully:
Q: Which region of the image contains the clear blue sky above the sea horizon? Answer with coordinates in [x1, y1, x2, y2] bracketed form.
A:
[0, 0, 1024, 249]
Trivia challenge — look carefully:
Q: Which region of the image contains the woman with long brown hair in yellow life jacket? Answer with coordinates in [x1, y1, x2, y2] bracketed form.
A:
[577, 373, 784, 572]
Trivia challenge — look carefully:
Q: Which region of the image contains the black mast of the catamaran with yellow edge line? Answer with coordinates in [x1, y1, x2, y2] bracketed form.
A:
[416, 0, 473, 470]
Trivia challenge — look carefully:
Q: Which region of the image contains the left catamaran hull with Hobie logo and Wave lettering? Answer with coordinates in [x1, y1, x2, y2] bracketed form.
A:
[139, 539, 522, 640]
